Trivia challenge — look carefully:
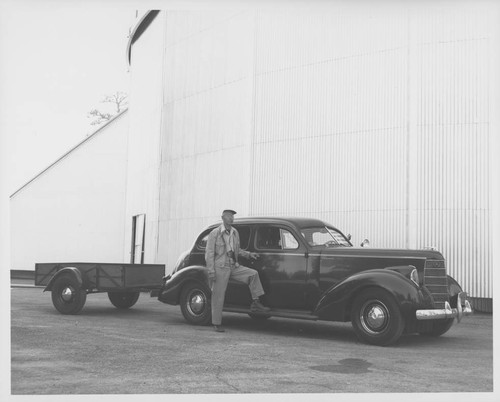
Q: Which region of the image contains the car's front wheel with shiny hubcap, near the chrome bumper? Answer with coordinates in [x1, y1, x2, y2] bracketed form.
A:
[351, 289, 404, 346]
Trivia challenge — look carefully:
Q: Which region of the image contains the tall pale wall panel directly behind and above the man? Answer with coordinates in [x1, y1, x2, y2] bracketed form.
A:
[154, 11, 253, 270]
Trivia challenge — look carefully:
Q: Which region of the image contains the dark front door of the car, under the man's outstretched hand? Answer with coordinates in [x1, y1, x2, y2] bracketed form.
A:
[251, 224, 307, 310]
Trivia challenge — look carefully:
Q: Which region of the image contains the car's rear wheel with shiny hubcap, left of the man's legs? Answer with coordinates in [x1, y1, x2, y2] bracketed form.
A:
[180, 283, 212, 325]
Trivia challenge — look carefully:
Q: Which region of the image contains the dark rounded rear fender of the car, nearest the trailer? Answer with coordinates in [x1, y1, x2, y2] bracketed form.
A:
[158, 265, 210, 305]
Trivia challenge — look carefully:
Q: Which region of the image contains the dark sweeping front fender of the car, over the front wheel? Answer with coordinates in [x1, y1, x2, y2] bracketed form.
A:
[314, 269, 424, 321]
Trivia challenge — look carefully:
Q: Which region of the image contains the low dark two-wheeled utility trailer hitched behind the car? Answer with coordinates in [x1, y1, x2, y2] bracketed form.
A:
[35, 262, 165, 314]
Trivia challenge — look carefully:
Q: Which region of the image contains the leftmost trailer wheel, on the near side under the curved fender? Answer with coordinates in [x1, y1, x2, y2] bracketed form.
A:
[52, 274, 87, 314]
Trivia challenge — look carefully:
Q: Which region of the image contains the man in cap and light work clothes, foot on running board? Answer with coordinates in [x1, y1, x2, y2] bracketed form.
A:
[205, 209, 271, 332]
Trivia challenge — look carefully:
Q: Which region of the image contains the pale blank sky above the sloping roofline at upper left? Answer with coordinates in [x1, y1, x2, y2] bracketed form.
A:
[0, 0, 135, 278]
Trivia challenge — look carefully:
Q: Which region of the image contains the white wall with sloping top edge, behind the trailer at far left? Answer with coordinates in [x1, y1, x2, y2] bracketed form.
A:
[10, 112, 128, 270]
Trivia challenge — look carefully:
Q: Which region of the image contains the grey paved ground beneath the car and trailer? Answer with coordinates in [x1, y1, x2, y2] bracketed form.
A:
[11, 288, 493, 394]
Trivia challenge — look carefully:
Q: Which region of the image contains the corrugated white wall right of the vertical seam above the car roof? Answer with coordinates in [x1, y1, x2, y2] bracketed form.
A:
[250, 7, 492, 297]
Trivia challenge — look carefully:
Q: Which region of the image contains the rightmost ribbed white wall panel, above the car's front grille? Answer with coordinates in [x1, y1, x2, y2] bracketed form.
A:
[410, 9, 492, 297]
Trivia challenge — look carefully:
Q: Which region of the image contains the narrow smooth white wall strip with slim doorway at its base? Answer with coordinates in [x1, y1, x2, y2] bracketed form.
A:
[123, 14, 165, 263]
